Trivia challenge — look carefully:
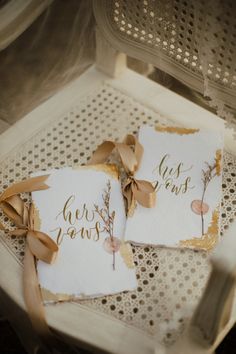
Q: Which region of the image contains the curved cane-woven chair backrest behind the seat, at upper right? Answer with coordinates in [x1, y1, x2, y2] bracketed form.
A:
[94, 0, 236, 119]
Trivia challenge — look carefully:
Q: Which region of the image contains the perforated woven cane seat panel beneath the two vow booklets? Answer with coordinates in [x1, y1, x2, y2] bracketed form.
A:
[0, 83, 236, 343]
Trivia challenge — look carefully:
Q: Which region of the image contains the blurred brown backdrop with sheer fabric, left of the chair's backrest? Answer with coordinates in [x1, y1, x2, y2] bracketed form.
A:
[0, 0, 95, 131]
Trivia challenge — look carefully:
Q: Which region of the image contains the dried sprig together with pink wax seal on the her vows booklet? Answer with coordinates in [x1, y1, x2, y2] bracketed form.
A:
[94, 180, 120, 270]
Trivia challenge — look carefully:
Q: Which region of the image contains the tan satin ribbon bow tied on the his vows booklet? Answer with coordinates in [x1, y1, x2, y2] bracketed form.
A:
[88, 134, 156, 216]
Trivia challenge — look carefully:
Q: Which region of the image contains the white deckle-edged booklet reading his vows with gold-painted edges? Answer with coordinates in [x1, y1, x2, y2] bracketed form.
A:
[125, 126, 223, 250]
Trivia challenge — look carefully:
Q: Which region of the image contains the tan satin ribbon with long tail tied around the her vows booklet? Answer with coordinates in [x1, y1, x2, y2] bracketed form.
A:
[0, 175, 58, 342]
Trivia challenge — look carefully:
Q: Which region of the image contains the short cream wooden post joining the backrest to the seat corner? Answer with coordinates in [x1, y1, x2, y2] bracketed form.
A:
[96, 28, 126, 77]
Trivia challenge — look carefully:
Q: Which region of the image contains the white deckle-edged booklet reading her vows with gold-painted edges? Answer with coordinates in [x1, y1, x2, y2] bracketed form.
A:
[32, 165, 136, 301]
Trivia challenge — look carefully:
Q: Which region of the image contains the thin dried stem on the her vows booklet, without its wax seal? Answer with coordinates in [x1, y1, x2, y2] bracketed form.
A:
[94, 180, 115, 270]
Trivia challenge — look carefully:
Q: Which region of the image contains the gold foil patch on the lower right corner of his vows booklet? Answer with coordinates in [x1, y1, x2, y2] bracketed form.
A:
[179, 208, 219, 251]
